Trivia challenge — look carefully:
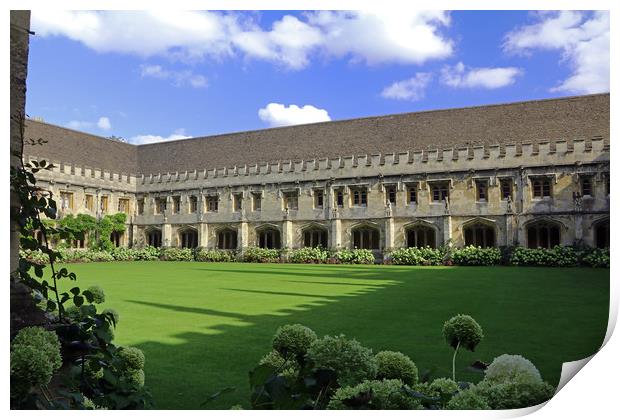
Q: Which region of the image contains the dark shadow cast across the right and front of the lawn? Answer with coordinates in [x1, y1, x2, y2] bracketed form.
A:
[123, 266, 608, 409]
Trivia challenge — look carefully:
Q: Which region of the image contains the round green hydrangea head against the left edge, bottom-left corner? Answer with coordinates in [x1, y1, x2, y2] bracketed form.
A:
[11, 344, 54, 400]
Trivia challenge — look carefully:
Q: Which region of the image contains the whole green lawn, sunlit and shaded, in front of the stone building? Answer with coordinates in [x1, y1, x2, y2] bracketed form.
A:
[55, 262, 609, 409]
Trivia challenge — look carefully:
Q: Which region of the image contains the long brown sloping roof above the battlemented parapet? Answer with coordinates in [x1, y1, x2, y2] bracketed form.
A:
[23, 94, 610, 174]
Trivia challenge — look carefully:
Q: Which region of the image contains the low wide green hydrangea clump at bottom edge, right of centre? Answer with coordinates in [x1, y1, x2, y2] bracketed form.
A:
[327, 379, 423, 410]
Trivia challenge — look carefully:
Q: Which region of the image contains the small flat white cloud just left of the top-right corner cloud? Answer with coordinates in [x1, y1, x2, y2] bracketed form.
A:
[441, 62, 522, 89]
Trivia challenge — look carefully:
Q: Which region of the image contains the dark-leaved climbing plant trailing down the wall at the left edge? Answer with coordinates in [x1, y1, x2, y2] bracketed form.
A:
[10, 114, 153, 409]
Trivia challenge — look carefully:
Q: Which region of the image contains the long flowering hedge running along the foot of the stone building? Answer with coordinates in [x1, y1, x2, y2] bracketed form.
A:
[19, 246, 610, 268]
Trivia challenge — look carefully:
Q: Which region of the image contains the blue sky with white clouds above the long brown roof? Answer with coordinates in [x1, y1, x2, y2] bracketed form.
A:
[27, 11, 609, 143]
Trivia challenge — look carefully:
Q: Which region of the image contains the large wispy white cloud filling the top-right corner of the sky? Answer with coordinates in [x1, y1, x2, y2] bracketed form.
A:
[503, 11, 610, 93]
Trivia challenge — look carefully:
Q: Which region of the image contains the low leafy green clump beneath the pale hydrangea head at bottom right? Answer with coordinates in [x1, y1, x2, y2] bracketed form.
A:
[472, 380, 555, 410]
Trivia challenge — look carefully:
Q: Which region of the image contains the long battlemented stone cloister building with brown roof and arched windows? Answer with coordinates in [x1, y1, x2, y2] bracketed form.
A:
[26, 94, 610, 253]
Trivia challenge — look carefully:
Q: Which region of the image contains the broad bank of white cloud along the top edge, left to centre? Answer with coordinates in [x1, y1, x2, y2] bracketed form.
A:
[31, 9, 452, 69]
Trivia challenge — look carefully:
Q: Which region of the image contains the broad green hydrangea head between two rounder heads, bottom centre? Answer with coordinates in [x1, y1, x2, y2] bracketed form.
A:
[307, 335, 377, 386]
